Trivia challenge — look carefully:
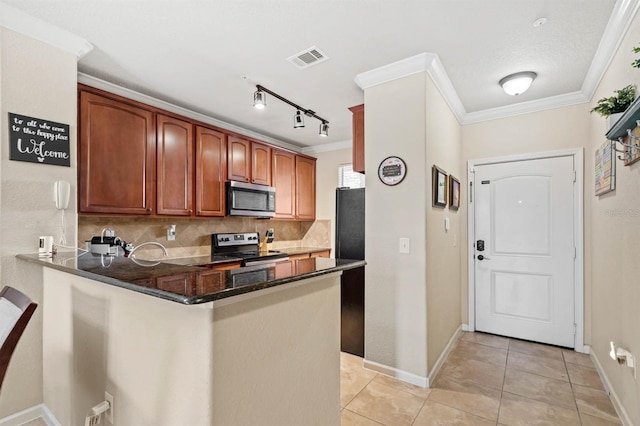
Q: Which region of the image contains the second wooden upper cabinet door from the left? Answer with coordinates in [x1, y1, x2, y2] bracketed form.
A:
[156, 114, 193, 216]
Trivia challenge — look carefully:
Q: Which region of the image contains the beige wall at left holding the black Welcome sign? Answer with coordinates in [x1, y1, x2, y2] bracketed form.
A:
[0, 27, 77, 418]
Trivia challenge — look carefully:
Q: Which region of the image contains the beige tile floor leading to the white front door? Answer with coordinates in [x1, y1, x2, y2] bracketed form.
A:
[340, 333, 621, 426]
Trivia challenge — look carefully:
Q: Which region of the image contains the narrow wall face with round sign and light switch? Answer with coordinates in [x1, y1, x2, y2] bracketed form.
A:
[365, 73, 430, 379]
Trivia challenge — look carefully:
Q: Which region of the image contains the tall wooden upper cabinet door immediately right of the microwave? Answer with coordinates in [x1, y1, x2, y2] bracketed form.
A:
[271, 149, 296, 219]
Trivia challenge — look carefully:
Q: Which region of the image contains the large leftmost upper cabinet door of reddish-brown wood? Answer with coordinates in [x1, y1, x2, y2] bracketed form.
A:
[78, 91, 156, 214]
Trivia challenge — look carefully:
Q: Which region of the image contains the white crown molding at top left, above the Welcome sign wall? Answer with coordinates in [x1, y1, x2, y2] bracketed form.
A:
[0, 2, 93, 60]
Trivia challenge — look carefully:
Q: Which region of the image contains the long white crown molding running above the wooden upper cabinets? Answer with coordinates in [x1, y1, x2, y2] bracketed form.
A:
[78, 72, 301, 152]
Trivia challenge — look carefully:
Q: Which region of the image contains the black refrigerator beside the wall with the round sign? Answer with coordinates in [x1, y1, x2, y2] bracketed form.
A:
[335, 188, 364, 357]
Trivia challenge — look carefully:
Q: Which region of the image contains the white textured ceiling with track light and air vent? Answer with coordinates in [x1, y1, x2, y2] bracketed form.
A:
[4, 0, 615, 147]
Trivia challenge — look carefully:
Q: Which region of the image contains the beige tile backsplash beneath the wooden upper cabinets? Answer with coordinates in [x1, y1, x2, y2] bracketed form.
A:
[78, 216, 331, 258]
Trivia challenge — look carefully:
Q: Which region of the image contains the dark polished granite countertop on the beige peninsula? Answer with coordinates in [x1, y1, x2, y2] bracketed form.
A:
[16, 252, 366, 305]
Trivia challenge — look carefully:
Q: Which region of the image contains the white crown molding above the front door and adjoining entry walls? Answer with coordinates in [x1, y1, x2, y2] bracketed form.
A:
[354, 0, 640, 125]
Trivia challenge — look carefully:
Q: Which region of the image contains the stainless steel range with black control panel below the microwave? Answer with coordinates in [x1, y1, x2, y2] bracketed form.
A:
[211, 232, 289, 266]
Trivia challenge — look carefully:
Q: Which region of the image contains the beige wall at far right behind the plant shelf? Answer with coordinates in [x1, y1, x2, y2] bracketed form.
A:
[584, 9, 640, 425]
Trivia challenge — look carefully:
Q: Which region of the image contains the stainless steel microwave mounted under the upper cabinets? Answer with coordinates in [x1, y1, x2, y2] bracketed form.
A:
[227, 181, 276, 217]
